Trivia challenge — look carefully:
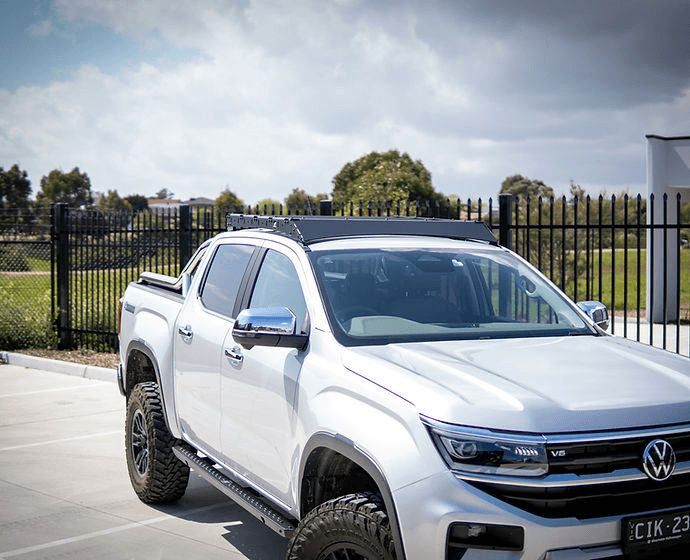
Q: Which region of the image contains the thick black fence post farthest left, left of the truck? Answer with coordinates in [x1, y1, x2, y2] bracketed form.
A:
[52, 202, 72, 350]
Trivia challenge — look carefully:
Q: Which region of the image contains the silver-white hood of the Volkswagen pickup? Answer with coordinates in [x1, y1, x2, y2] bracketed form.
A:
[343, 336, 690, 434]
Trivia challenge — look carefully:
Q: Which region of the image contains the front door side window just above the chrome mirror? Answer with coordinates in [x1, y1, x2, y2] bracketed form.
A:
[249, 250, 307, 331]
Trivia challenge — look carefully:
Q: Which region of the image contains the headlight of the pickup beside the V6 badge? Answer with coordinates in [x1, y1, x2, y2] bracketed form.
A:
[427, 423, 549, 476]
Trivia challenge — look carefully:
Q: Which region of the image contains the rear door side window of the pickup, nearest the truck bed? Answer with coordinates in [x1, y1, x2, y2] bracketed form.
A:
[201, 245, 254, 317]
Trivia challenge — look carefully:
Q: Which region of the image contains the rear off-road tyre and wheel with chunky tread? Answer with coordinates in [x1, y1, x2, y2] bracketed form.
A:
[125, 383, 189, 504]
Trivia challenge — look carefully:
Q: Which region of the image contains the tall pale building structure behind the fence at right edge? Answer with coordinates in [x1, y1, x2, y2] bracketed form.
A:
[647, 134, 690, 323]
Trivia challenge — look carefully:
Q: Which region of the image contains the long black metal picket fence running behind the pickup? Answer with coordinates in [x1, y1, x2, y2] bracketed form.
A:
[0, 195, 690, 353]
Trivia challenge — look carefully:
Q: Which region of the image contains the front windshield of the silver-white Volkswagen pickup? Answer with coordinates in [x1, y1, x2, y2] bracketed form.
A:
[310, 248, 594, 346]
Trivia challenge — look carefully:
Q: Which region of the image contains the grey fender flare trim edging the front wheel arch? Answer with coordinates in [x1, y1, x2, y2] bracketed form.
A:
[298, 432, 405, 560]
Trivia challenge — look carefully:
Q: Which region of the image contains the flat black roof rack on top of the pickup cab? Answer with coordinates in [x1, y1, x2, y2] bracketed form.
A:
[227, 214, 497, 245]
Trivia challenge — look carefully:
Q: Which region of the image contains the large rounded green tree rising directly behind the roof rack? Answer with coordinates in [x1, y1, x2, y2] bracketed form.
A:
[333, 150, 443, 206]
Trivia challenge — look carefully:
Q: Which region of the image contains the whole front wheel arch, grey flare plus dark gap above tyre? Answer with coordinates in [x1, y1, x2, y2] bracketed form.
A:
[298, 432, 405, 560]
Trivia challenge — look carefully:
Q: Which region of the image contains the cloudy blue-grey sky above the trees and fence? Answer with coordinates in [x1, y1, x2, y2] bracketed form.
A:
[0, 0, 690, 203]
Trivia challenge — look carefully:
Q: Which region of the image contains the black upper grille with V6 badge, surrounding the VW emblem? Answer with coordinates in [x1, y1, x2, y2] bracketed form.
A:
[546, 433, 690, 475]
